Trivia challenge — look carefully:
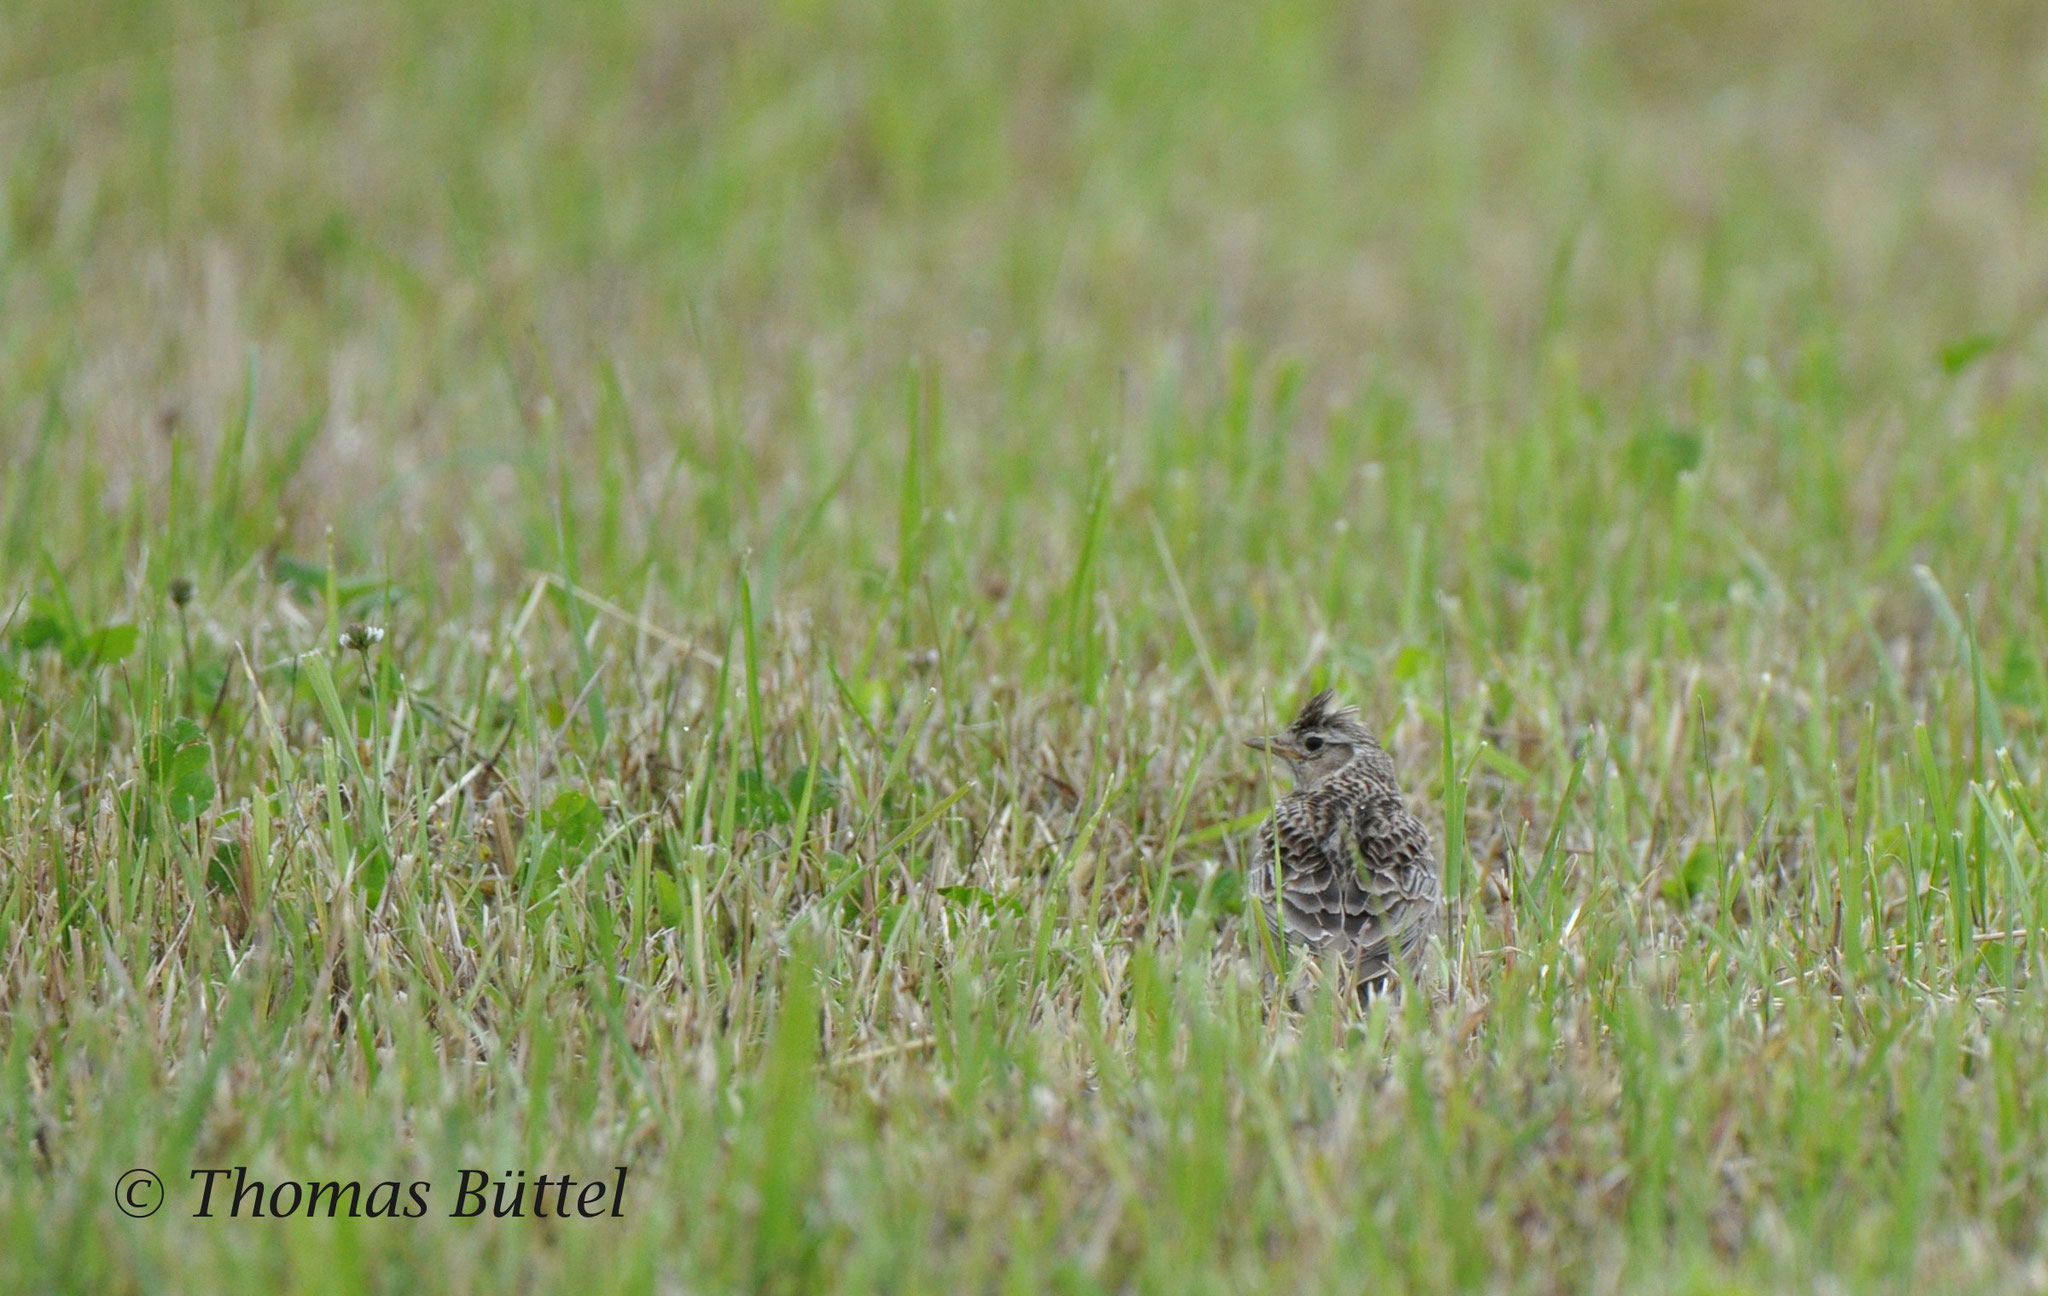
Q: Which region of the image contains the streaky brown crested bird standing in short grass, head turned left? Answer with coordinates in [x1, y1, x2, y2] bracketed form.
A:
[1245, 688, 1442, 1001]
